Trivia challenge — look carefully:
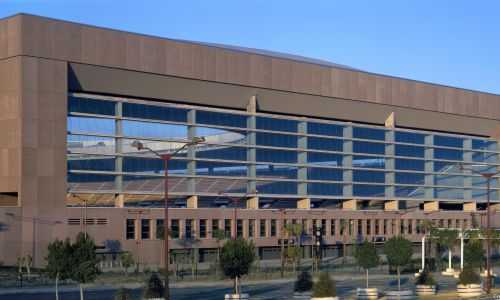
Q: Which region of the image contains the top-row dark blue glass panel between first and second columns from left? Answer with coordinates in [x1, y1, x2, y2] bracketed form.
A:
[122, 102, 188, 122]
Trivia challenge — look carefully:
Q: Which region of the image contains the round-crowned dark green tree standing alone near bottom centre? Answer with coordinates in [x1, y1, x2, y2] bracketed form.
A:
[219, 238, 255, 294]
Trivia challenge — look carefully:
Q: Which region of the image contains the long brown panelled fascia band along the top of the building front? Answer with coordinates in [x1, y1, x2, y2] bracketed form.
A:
[3, 15, 500, 120]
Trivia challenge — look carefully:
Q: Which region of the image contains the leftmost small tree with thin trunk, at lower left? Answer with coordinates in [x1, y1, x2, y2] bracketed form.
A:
[45, 239, 71, 300]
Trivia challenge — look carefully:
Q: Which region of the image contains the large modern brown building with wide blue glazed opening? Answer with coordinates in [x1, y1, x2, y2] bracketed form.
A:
[0, 14, 500, 266]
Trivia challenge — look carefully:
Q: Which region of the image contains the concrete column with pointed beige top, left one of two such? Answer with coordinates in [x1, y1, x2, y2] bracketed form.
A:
[247, 96, 257, 193]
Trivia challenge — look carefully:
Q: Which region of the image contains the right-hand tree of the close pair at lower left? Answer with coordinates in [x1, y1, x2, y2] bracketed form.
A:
[70, 232, 99, 300]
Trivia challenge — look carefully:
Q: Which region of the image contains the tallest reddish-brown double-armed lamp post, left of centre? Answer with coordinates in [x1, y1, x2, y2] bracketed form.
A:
[131, 137, 205, 300]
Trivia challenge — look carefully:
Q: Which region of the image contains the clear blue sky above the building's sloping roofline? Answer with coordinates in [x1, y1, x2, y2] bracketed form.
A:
[0, 0, 500, 94]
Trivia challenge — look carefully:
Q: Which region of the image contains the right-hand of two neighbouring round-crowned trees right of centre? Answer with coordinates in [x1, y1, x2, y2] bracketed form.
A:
[384, 236, 413, 290]
